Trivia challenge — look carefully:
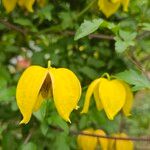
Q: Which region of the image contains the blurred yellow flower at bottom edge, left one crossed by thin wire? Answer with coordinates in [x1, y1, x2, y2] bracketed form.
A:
[77, 128, 108, 150]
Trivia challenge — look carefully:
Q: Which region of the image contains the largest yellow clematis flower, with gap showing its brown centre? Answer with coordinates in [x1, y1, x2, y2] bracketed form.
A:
[16, 61, 81, 124]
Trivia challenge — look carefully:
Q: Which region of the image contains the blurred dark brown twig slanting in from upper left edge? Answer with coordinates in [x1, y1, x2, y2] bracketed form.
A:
[0, 18, 27, 35]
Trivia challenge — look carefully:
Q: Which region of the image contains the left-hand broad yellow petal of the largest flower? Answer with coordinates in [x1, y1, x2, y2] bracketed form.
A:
[16, 66, 47, 124]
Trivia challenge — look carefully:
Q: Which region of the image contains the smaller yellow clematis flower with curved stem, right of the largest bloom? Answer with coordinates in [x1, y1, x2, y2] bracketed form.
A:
[81, 74, 133, 120]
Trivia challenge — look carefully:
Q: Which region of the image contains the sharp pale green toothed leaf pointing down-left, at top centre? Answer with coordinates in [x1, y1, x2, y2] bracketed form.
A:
[74, 19, 103, 40]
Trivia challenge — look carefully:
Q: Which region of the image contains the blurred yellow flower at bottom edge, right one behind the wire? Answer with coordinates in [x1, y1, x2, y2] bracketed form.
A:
[108, 133, 134, 150]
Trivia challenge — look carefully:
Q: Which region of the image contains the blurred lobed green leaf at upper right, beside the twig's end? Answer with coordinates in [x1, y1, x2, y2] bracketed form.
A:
[115, 30, 137, 53]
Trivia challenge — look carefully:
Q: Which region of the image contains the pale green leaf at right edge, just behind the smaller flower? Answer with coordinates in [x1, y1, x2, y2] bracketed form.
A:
[116, 70, 150, 91]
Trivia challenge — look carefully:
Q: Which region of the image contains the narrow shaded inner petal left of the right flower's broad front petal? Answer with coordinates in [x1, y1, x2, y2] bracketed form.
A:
[94, 83, 103, 111]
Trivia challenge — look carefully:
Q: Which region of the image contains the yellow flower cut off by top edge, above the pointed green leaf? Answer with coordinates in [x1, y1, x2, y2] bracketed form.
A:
[98, 0, 130, 18]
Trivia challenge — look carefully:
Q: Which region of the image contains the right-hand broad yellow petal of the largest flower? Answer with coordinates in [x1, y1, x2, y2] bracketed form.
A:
[49, 68, 81, 122]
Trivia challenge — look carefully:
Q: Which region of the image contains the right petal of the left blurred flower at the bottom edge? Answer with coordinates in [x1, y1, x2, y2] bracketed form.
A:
[94, 129, 108, 150]
